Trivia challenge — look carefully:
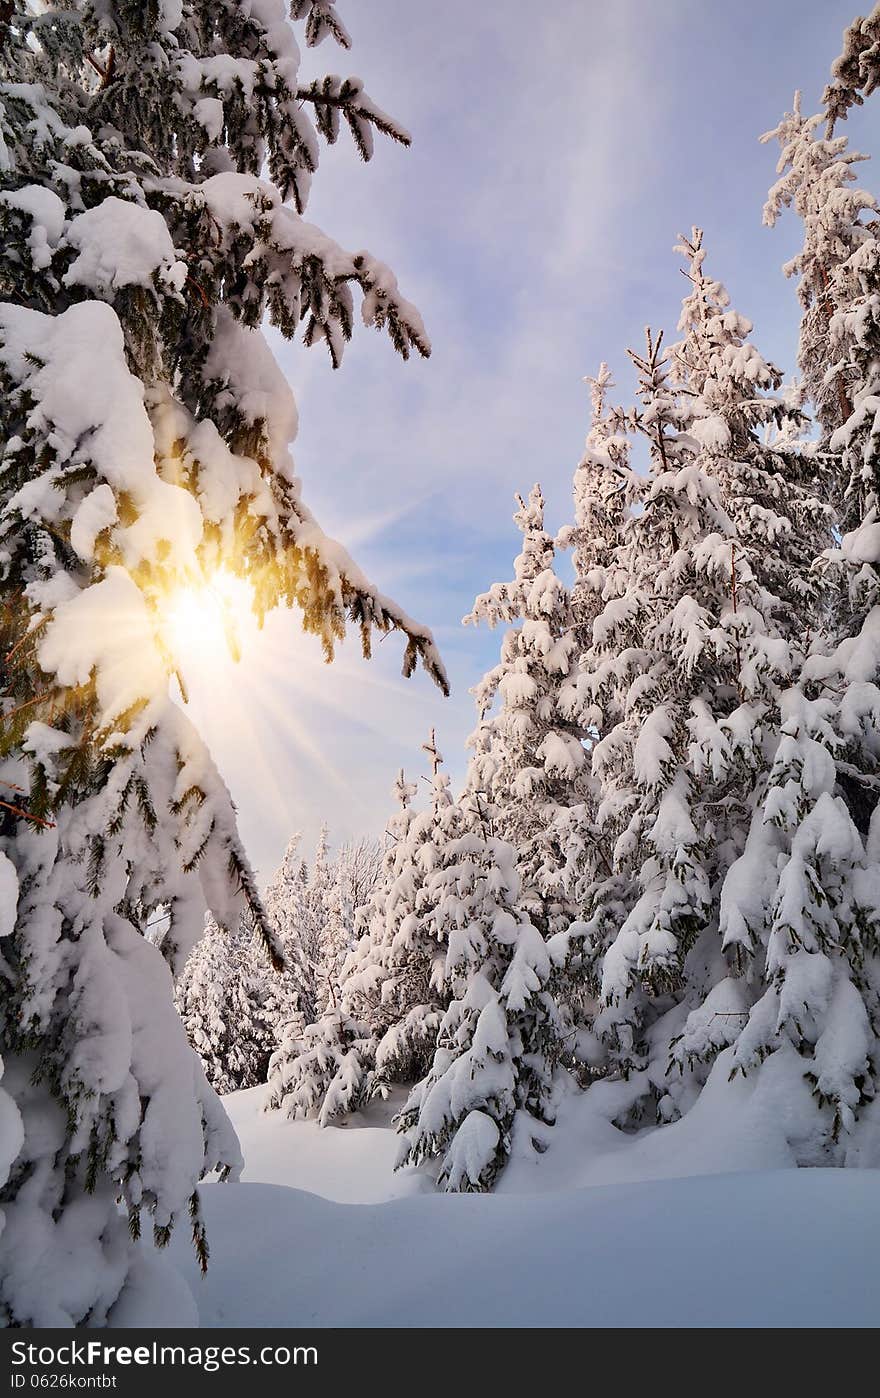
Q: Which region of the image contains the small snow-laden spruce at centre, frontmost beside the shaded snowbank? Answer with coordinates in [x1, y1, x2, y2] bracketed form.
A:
[397, 794, 568, 1190]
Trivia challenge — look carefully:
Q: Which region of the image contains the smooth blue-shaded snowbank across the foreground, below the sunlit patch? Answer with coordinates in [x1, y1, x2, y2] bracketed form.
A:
[173, 1168, 880, 1328]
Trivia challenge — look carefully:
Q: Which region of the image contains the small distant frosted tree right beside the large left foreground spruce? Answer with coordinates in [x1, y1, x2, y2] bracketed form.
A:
[175, 918, 274, 1093]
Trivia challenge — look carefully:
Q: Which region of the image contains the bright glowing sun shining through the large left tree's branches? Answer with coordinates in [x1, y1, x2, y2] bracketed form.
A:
[162, 569, 253, 674]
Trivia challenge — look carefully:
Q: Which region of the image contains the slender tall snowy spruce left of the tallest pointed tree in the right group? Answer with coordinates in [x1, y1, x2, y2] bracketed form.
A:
[565, 330, 699, 1100]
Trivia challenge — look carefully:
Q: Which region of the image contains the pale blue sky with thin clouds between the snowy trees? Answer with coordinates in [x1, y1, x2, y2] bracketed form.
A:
[181, 0, 880, 879]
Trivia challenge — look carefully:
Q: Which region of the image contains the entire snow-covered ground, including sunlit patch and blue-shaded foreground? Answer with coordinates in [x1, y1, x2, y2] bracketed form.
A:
[173, 1089, 880, 1327]
